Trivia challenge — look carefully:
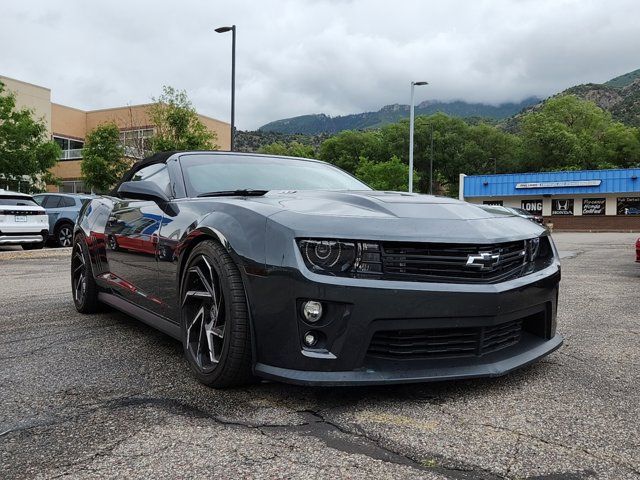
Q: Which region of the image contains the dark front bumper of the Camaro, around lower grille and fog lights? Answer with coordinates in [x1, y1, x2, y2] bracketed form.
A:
[245, 255, 562, 385]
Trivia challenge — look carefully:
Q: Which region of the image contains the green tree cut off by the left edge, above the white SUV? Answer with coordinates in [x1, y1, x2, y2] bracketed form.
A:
[0, 82, 61, 189]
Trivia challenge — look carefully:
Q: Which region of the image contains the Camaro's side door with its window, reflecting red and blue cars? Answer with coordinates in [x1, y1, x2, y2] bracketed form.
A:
[105, 164, 169, 314]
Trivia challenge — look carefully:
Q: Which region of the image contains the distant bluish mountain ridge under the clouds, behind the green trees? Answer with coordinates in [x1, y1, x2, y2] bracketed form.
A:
[258, 97, 540, 135]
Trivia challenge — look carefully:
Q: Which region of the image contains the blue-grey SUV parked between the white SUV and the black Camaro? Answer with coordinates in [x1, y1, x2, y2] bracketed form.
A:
[33, 193, 92, 247]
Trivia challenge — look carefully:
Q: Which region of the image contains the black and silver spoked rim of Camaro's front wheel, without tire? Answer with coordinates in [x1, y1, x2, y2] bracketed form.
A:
[182, 255, 226, 373]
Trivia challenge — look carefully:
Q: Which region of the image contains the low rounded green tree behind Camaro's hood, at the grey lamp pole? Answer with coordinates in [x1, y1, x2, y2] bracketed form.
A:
[356, 155, 420, 192]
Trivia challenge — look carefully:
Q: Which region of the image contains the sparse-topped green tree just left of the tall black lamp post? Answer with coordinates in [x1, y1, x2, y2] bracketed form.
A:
[147, 85, 218, 153]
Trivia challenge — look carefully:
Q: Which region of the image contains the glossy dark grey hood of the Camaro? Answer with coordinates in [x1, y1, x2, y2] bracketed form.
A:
[251, 191, 545, 243]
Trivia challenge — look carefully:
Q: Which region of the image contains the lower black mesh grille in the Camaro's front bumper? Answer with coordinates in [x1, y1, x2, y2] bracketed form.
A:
[367, 319, 522, 359]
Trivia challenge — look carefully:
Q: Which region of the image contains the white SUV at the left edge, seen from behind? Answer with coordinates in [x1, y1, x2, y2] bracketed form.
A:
[0, 189, 49, 250]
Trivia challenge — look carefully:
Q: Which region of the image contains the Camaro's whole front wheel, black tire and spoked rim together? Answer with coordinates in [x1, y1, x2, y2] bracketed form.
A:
[181, 240, 252, 388]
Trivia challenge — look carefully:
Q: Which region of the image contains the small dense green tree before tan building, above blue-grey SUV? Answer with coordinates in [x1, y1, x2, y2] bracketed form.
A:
[80, 123, 131, 192]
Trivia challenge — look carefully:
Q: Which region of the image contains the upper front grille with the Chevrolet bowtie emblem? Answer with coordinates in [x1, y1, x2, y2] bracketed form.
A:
[382, 240, 528, 283]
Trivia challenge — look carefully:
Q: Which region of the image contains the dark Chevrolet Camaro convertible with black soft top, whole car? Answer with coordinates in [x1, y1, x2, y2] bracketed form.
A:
[71, 152, 562, 387]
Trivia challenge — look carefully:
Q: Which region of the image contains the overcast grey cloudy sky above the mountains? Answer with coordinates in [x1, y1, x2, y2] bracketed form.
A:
[0, 0, 640, 129]
